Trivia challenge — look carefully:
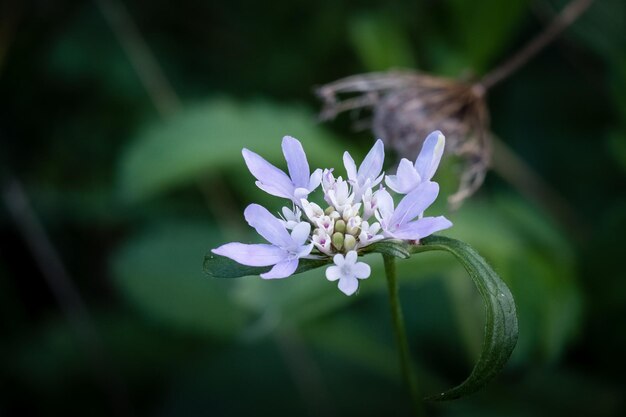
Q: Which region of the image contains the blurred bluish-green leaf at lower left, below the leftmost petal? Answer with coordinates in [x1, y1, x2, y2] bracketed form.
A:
[112, 222, 246, 336]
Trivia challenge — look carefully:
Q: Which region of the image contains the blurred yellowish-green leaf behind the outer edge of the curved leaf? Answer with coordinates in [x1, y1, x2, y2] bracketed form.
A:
[450, 197, 582, 364]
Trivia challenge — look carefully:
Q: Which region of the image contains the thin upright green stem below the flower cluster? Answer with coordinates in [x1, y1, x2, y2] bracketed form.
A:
[383, 254, 423, 416]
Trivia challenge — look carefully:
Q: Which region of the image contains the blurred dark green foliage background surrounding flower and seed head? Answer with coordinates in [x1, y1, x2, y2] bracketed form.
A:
[0, 0, 626, 416]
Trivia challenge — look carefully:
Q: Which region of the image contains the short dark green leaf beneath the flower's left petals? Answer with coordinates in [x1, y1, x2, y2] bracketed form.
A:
[204, 252, 330, 278]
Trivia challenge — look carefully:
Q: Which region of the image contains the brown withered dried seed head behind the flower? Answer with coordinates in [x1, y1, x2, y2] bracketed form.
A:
[317, 71, 491, 211]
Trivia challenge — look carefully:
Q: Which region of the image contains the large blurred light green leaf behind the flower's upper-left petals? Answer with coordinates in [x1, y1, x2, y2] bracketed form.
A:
[118, 99, 343, 201]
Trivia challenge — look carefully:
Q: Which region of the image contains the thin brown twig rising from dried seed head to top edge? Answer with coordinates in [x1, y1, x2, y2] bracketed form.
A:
[478, 0, 593, 91]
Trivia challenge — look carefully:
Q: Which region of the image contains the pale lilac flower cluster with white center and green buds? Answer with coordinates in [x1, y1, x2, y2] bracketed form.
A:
[213, 131, 452, 295]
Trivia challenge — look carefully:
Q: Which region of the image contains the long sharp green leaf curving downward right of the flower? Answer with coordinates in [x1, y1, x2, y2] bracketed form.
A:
[380, 236, 518, 401]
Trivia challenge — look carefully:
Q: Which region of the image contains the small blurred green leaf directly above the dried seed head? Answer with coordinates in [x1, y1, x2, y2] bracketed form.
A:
[349, 13, 416, 71]
